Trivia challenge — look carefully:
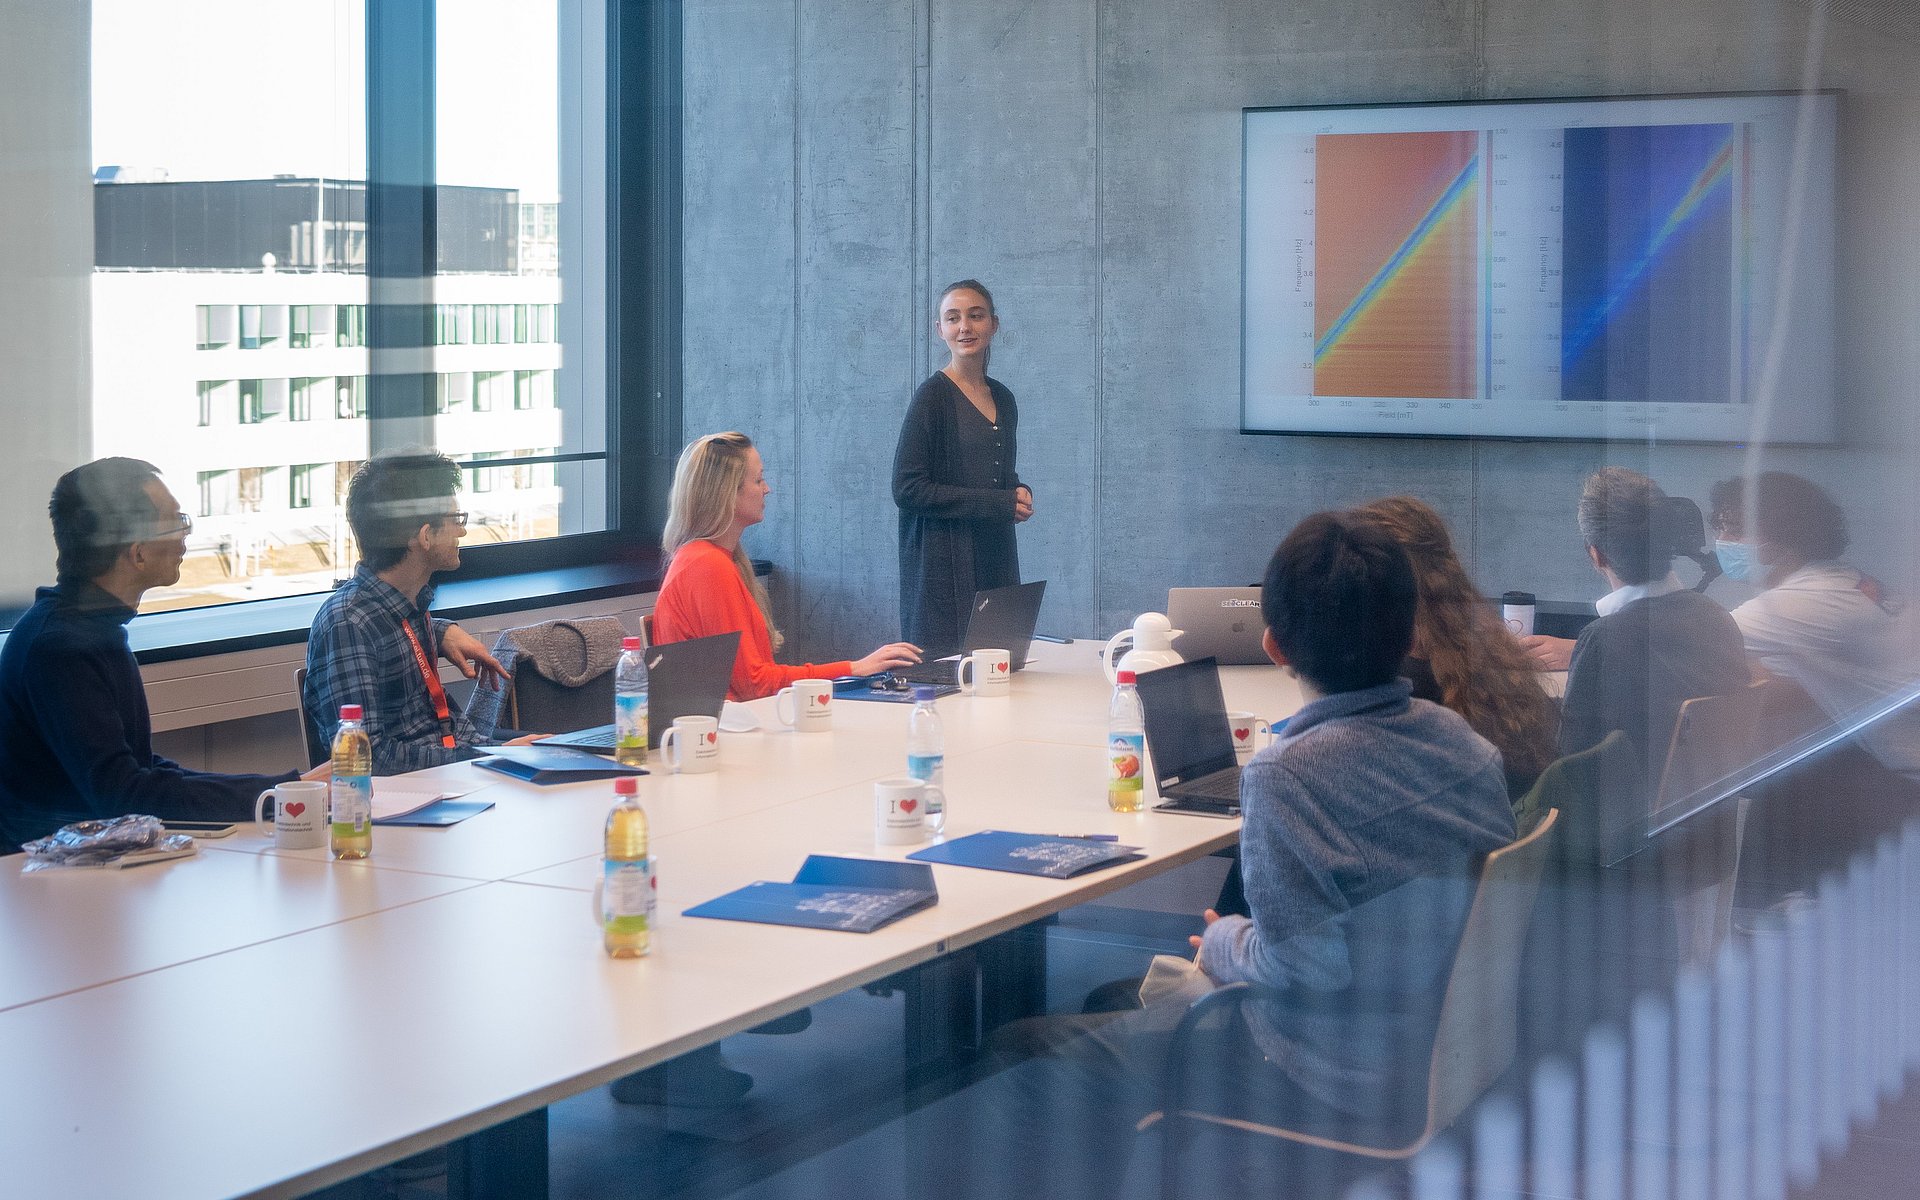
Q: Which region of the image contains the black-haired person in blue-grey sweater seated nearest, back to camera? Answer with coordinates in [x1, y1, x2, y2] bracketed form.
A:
[918, 513, 1515, 1198]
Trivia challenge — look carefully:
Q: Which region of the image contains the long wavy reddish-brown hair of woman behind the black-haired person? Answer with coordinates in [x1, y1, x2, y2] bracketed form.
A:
[1354, 495, 1559, 801]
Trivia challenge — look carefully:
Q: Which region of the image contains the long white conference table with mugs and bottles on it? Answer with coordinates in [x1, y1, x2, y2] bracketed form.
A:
[0, 641, 1300, 1200]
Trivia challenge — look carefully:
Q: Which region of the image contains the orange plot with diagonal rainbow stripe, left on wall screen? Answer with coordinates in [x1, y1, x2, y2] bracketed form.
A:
[1313, 132, 1480, 399]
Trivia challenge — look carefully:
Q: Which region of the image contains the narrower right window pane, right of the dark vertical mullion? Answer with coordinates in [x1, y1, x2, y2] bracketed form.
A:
[434, 0, 607, 547]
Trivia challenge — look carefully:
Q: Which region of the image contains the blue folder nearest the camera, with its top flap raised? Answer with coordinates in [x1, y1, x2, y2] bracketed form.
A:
[684, 854, 941, 933]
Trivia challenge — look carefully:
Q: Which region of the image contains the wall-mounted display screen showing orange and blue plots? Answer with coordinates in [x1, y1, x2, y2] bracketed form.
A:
[1240, 94, 1837, 442]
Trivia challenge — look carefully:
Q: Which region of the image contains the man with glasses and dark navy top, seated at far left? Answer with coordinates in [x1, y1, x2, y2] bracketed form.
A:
[0, 459, 330, 852]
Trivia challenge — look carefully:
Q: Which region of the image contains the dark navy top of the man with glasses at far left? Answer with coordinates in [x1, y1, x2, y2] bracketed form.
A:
[0, 584, 298, 854]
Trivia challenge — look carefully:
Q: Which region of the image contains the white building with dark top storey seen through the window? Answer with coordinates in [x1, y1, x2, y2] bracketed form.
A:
[92, 179, 563, 607]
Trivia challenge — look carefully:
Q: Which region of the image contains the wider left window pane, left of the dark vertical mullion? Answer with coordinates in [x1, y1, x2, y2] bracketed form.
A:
[86, 0, 367, 611]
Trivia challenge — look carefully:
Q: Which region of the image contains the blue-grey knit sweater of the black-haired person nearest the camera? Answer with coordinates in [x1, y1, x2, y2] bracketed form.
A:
[1200, 680, 1513, 1119]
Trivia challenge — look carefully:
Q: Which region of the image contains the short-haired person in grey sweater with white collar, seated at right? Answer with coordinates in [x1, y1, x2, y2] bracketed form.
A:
[1559, 467, 1749, 799]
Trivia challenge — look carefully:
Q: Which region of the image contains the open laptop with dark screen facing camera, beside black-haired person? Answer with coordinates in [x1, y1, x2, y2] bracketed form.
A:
[1135, 659, 1240, 816]
